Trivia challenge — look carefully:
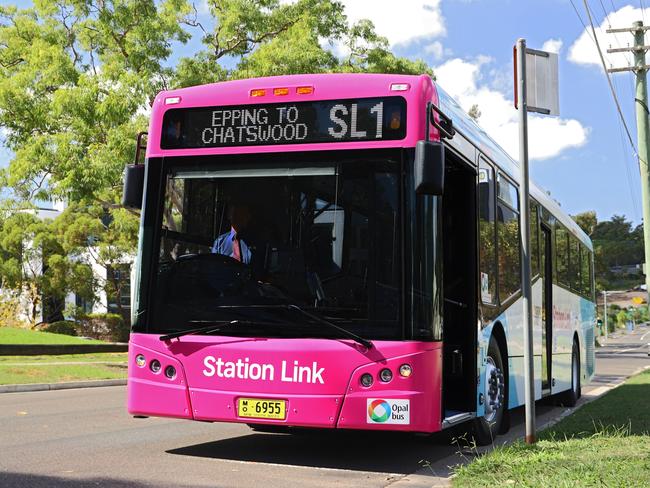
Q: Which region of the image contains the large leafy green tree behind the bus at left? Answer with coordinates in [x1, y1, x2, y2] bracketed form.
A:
[0, 0, 432, 316]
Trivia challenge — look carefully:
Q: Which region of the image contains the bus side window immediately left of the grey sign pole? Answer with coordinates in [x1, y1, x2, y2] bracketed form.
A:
[497, 178, 521, 303]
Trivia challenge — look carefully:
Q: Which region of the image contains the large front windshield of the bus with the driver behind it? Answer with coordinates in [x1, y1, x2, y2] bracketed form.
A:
[151, 158, 403, 339]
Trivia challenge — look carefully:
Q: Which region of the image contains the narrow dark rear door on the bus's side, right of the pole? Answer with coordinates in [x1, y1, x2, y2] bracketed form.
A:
[540, 225, 553, 396]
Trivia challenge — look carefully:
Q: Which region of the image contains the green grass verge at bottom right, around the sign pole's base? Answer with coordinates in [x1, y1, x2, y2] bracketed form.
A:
[453, 371, 650, 488]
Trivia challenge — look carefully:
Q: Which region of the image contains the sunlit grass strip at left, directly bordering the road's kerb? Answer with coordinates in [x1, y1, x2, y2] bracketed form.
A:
[0, 353, 127, 385]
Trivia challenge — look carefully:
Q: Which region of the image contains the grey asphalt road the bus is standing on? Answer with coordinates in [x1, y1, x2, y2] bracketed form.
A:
[0, 327, 650, 488]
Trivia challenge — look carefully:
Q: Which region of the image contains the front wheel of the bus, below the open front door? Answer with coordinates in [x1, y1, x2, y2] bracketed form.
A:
[474, 337, 508, 446]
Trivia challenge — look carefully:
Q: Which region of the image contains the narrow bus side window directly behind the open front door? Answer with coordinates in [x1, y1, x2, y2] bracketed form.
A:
[478, 164, 497, 304]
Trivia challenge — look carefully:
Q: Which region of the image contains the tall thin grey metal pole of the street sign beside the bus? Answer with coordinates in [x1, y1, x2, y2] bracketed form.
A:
[516, 39, 535, 444]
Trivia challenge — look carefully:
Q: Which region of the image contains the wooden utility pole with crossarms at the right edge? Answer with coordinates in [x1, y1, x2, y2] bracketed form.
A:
[607, 20, 650, 303]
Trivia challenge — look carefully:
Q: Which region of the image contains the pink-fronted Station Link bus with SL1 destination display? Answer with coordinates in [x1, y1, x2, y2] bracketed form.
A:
[124, 74, 594, 442]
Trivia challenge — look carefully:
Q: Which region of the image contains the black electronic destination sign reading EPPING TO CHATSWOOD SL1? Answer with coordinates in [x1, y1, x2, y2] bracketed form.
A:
[161, 97, 406, 149]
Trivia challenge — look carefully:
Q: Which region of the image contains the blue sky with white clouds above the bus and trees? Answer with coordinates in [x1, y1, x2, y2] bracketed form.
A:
[0, 0, 650, 224]
